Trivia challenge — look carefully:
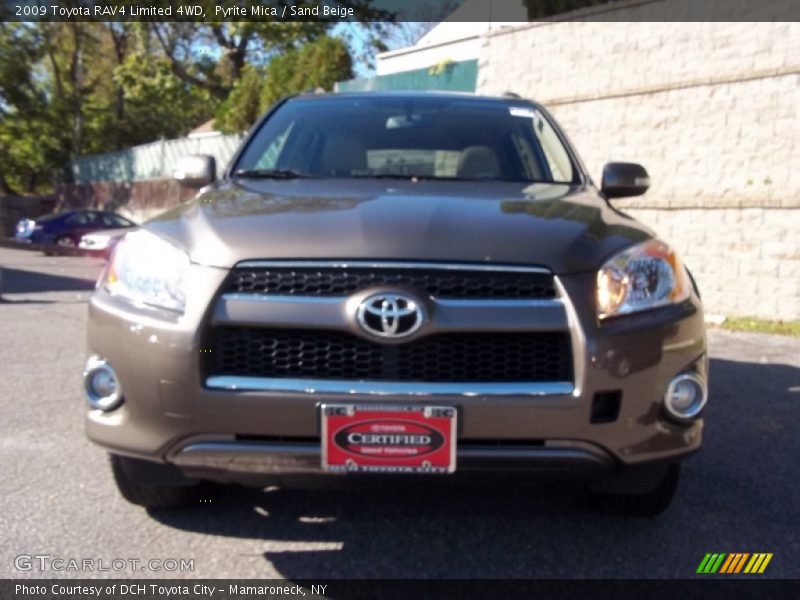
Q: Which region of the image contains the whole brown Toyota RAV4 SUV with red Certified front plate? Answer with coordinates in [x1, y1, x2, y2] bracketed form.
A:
[84, 92, 707, 515]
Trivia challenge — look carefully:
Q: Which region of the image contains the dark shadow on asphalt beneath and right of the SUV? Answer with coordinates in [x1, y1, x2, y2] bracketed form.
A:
[150, 360, 800, 579]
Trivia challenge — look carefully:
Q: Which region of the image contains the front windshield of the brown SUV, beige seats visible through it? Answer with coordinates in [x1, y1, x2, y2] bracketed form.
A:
[233, 96, 576, 183]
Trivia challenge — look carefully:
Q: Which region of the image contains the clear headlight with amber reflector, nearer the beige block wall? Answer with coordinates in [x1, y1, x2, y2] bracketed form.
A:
[597, 240, 689, 319]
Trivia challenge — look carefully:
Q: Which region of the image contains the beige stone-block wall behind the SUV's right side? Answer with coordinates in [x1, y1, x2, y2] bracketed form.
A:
[477, 17, 800, 319]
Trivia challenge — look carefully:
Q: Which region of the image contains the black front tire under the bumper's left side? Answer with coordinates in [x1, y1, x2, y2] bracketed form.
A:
[109, 454, 207, 508]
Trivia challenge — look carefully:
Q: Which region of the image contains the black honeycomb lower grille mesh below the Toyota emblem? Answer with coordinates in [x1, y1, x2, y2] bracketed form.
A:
[206, 327, 572, 382]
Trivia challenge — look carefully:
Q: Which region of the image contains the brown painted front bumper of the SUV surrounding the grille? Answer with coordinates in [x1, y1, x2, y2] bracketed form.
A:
[86, 266, 707, 480]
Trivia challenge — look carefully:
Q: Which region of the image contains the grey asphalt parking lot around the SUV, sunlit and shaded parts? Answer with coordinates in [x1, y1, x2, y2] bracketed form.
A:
[0, 248, 800, 579]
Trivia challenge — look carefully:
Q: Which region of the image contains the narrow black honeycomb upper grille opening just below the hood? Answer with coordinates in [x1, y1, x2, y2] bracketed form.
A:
[224, 266, 556, 300]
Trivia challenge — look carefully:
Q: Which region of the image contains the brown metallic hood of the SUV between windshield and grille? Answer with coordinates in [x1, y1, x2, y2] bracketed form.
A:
[146, 179, 653, 274]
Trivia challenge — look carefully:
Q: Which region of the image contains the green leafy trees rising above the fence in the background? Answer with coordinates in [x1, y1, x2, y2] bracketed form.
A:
[0, 5, 391, 194]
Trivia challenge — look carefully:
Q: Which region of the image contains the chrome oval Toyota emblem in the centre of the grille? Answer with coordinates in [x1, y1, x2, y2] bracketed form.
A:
[356, 294, 424, 338]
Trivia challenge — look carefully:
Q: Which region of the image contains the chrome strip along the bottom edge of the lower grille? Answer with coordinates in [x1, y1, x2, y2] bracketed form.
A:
[206, 375, 574, 397]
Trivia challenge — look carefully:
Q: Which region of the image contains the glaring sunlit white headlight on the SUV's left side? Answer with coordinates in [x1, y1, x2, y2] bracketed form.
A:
[104, 230, 189, 313]
